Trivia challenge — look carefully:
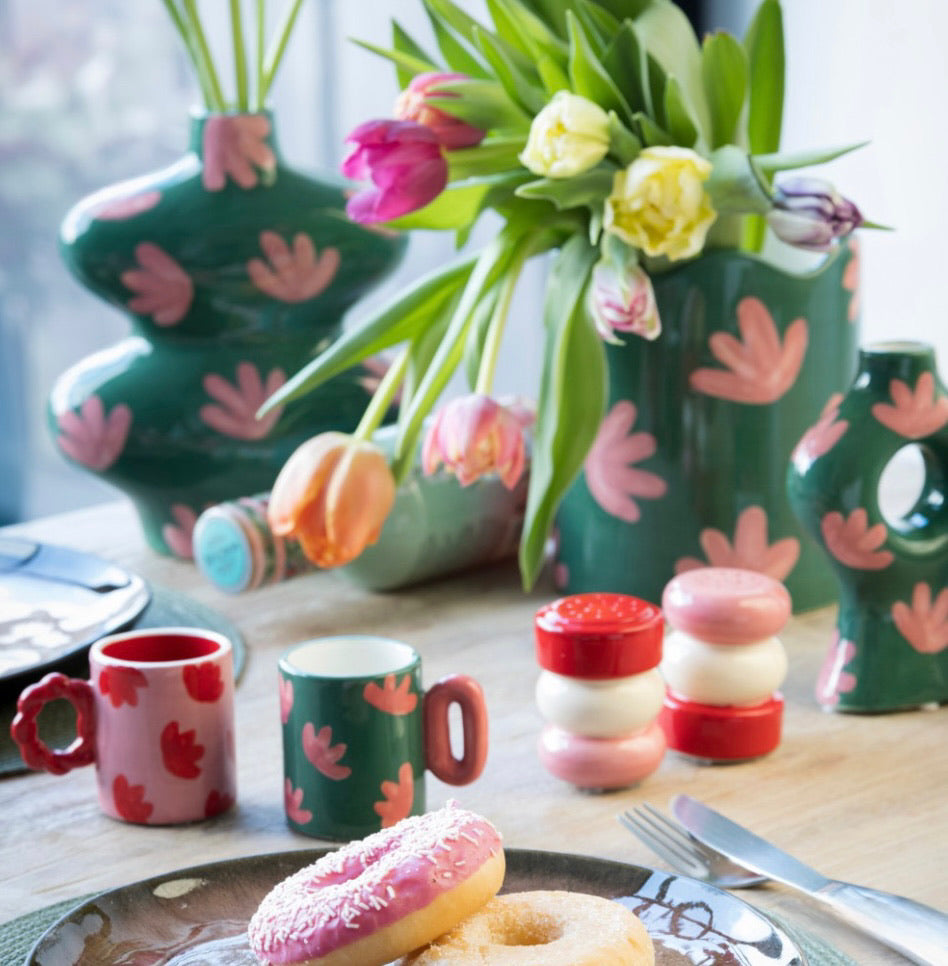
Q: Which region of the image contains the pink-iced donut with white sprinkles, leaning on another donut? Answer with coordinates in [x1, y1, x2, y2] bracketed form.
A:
[247, 803, 505, 966]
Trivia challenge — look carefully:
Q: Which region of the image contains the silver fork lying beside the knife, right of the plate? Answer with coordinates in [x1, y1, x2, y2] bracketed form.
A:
[618, 802, 770, 889]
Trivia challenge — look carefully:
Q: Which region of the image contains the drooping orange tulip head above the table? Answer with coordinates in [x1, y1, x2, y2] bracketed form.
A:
[267, 433, 395, 568]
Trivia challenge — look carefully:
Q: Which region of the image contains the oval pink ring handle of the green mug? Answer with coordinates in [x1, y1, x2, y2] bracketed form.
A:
[423, 674, 487, 785]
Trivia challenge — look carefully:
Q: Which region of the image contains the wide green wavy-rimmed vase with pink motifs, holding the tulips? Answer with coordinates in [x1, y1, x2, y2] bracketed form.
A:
[555, 244, 858, 611]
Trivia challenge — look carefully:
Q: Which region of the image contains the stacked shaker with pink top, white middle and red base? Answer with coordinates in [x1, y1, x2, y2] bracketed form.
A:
[659, 567, 791, 764]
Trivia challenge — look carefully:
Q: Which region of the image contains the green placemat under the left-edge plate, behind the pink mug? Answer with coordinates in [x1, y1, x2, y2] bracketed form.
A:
[0, 586, 247, 780]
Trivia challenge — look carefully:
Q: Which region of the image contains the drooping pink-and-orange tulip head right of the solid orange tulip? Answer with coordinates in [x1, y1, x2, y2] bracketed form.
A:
[422, 393, 528, 490]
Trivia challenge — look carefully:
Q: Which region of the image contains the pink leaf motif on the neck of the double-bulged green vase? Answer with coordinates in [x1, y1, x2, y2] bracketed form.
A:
[201, 114, 276, 191]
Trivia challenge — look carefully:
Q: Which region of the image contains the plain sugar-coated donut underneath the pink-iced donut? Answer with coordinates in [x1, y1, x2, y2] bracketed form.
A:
[399, 892, 655, 966]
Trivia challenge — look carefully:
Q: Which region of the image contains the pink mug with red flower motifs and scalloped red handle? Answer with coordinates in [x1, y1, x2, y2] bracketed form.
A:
[10, 627, 237, 825]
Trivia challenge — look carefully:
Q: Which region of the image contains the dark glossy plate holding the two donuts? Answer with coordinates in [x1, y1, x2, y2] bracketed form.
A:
[27, 849, 806, 966]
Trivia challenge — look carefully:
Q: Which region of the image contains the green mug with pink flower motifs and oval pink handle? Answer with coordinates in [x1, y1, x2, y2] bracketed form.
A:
[280, 636, 487, 840]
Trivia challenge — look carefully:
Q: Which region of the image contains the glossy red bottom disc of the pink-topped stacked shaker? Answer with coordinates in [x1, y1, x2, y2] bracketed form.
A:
[658, 691, 783, 761]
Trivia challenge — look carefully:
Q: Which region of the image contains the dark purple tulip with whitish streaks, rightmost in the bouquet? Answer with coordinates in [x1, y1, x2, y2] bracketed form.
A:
[767, 178, 863, 252]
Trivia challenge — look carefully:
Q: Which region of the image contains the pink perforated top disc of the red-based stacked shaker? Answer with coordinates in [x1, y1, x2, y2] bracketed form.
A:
[662, 567, 791, 645]
